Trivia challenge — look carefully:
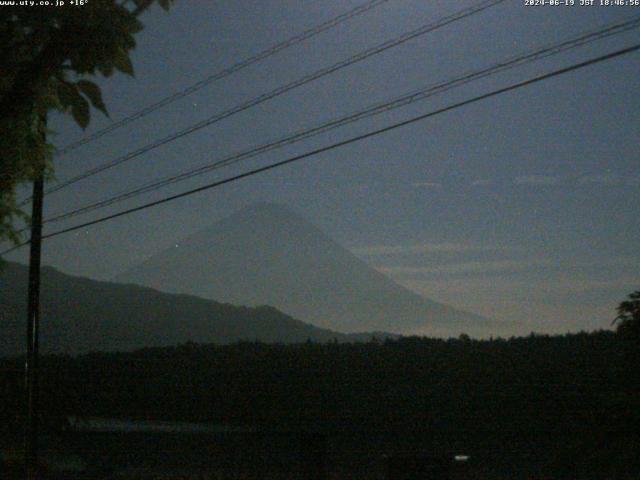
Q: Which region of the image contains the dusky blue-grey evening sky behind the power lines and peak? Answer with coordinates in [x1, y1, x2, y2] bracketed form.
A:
[7, 0, 640, 334]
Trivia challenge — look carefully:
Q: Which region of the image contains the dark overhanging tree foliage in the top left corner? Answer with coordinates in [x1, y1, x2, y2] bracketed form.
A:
[0, 0, 173, 251]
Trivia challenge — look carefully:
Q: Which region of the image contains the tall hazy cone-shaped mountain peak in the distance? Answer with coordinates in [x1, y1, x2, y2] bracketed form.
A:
[117, 203, 487, 336]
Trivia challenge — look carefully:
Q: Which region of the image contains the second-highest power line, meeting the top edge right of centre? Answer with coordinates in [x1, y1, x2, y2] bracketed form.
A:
[28, 0, 505, 205]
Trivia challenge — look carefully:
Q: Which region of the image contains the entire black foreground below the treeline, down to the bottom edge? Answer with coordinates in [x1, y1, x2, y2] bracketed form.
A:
[2, 332, 640, 479]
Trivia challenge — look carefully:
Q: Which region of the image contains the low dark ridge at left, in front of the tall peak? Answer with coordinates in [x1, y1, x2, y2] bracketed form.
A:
[0, 263, 378, 355]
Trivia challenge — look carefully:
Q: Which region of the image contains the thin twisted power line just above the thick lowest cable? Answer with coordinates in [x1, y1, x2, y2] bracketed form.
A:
[37, 16, 640, 225]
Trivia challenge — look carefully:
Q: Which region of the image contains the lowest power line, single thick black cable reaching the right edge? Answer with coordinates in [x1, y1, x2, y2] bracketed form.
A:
[0, 44, 640, 256]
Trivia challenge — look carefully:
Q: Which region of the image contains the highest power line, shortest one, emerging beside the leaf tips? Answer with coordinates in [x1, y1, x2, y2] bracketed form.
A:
[53, 0, 389, 155]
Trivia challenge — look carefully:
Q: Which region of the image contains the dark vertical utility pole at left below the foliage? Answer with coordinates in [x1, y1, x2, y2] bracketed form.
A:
[24, 117, 46, 480]
